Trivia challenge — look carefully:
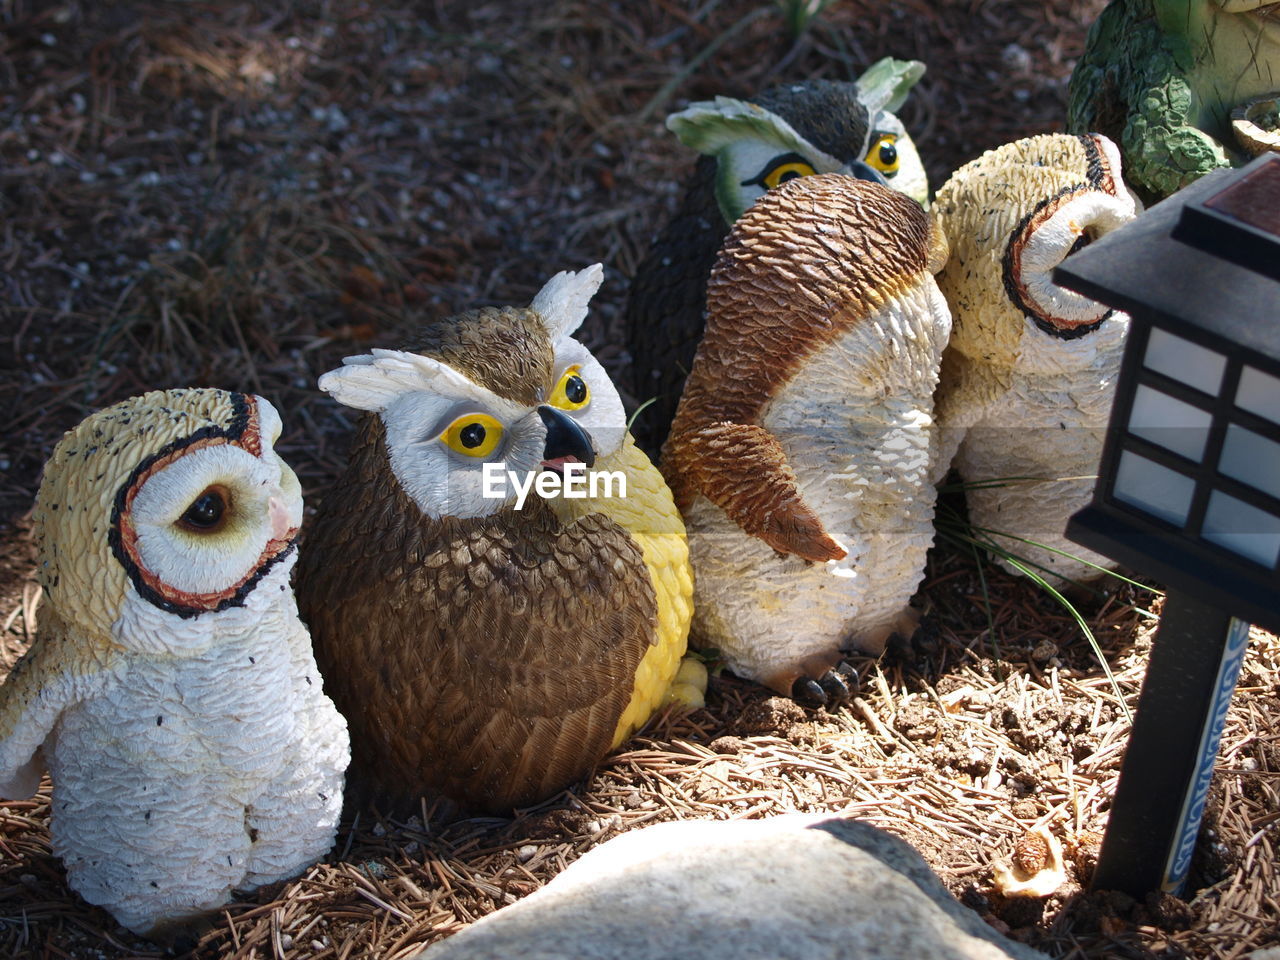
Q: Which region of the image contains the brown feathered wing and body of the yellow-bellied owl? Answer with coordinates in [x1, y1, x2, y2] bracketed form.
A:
[298, 417, 657, 813]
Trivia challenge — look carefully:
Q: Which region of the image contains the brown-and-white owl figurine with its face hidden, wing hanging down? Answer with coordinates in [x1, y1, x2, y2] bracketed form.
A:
[662, 174, 951, 704]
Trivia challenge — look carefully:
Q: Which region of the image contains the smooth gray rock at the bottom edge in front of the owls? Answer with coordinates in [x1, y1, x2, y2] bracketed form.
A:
[419, 815, 1044, 960]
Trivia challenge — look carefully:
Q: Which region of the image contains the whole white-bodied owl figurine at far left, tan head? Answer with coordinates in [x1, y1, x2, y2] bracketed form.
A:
[0, 389, 349, 934]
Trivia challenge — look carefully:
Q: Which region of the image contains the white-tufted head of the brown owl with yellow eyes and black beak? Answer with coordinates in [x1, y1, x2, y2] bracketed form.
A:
[320, 264, 626, 518]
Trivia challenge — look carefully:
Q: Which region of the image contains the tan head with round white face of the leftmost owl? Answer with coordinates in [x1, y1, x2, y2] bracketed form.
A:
[35, 389, 302, 636]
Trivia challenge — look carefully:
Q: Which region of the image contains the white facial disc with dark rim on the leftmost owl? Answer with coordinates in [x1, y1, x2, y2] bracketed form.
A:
[110, 397, 302, 617]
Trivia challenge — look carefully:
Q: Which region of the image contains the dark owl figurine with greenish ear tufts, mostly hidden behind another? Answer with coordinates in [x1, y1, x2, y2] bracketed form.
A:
[625, 59, 929, 453]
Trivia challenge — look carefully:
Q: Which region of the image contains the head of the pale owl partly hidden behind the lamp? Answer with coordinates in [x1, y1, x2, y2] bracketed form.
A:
[933, 133, 1139, 367]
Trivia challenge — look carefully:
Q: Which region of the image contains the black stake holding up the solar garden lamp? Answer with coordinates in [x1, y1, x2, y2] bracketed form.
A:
[1091, 593, 1249, 897]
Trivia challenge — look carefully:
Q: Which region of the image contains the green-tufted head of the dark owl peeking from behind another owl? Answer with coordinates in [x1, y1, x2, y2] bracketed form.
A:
[667, 59, 929, 224]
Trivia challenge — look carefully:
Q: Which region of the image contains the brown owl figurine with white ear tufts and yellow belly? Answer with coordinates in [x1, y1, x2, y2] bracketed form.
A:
[298, 264, 692, 814]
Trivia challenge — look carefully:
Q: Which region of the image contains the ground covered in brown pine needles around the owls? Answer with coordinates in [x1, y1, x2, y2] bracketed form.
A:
[0, 0, 1280, 960]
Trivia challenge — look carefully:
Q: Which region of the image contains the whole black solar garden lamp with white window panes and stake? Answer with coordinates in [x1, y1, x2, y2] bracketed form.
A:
[1055, 154, 1280, 897]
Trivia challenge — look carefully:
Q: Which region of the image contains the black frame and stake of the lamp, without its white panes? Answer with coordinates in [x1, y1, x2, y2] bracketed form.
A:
[1055, 156, 1280, 897]
